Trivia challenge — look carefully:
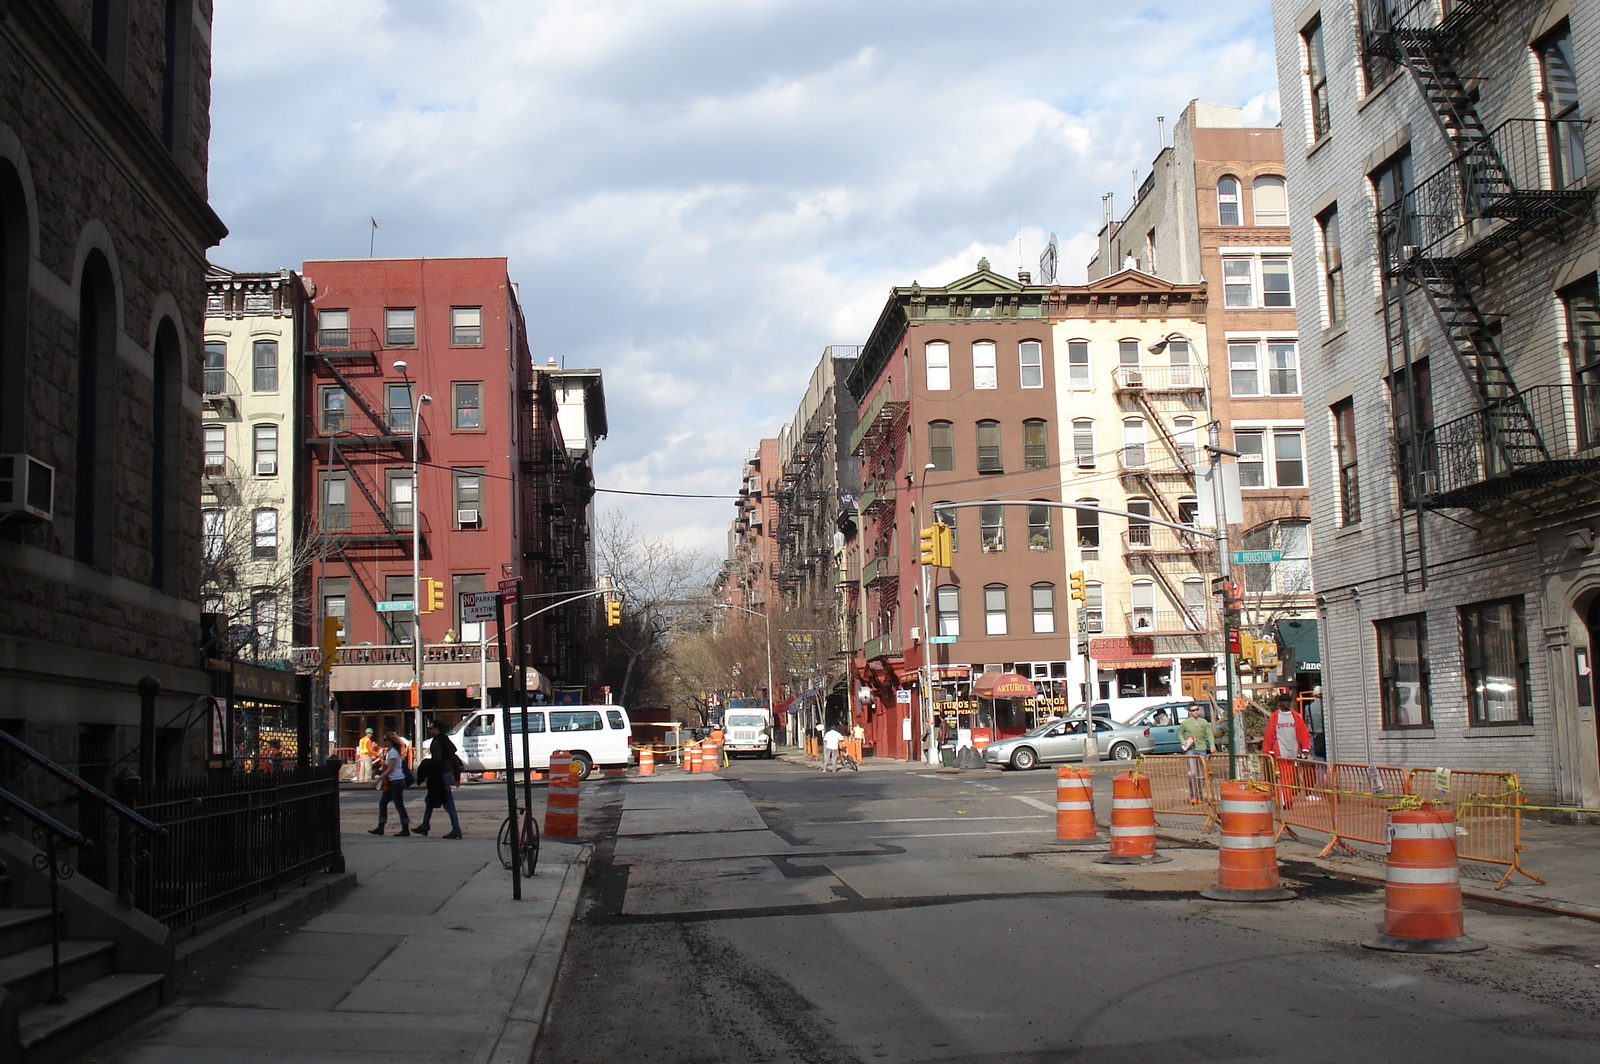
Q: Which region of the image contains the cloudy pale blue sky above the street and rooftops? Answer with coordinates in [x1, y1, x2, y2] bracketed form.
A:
[211, 0, 1278, 554]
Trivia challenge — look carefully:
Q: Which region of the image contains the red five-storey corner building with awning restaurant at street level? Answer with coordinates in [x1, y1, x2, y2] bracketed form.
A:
[304, 258, 590, 746]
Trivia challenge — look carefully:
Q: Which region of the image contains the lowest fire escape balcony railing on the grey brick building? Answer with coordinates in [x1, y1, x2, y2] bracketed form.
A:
[1400, 384, 1600, 507]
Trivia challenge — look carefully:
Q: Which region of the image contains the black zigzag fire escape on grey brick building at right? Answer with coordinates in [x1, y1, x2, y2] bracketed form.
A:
[1363, 0, 1600, 590]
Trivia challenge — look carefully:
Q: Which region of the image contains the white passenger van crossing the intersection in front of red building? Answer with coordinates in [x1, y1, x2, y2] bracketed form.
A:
[450, 706, 634, 779]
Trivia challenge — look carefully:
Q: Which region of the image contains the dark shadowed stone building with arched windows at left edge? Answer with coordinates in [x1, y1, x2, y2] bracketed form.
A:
[0, 0, 226, 771]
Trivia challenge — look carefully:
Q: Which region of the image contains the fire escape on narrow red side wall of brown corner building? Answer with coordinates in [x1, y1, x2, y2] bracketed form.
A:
[851, 378, 910, 661]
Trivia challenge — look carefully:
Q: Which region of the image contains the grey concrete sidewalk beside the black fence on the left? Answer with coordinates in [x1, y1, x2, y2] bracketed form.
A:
[83, 787, 589, 1064]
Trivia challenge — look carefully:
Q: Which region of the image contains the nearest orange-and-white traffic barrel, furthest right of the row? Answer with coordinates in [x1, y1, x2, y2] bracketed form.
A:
[1362, 803, 1483, 954]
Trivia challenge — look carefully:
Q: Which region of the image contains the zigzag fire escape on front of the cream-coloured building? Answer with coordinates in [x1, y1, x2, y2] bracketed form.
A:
[1112, 361, 1216, 635]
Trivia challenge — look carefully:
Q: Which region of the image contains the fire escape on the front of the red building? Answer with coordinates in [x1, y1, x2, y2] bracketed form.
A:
[307, 328, 429, 643]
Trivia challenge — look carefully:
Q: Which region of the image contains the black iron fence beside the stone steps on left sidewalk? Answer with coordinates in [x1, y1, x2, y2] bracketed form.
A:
[133, 763, 344, 926]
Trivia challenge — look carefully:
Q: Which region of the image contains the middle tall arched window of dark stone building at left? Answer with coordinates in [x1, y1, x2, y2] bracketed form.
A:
[72, 251, 117, 568]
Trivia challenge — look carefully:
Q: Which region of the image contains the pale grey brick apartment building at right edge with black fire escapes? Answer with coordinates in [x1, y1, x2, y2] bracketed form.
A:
[1274, 0, 1600, 806]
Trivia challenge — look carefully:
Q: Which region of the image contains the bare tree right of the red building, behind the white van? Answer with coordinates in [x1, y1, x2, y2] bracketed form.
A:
[595, 510, 717, 706]
